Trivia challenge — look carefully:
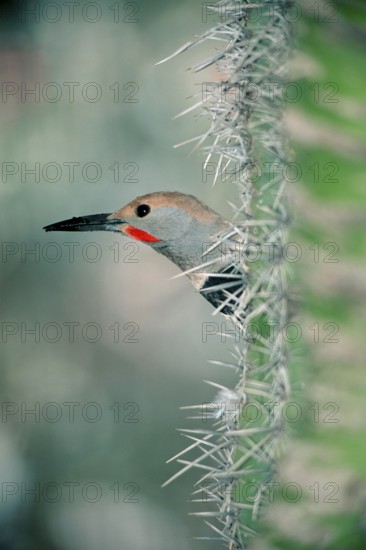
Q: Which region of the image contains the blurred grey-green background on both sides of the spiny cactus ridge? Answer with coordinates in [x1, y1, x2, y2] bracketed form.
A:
[0, 0, 366, 550]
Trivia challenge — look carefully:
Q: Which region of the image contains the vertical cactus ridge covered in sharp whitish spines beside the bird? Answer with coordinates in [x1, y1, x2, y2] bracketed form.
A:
[162, 0, 291, 549]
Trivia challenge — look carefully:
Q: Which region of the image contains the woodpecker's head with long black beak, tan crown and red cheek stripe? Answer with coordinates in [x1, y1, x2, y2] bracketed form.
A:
[44, 192, 230, 276]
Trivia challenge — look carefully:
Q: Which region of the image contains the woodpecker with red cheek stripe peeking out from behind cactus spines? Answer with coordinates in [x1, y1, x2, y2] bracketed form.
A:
[44, 191, 246, 314]
